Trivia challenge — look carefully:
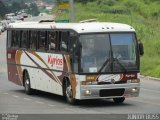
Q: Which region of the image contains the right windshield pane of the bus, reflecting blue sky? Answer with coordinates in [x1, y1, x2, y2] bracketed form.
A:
[110, 33, 137, 72]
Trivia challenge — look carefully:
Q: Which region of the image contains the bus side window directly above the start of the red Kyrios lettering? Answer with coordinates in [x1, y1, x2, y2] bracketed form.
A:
[48, 31, 56, 50]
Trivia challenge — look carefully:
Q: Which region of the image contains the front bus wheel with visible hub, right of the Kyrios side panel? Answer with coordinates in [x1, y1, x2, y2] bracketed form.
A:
[66, 81, 76, 105]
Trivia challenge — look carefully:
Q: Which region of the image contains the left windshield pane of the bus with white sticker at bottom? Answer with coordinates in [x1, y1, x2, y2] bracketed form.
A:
[80, 34, 110, 73]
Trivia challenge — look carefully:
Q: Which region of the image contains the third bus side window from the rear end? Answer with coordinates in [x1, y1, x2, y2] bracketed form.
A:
[21, 30, 28, 48]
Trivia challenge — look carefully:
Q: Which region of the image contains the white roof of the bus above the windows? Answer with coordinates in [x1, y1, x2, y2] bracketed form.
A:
[9, 22, 135, 33]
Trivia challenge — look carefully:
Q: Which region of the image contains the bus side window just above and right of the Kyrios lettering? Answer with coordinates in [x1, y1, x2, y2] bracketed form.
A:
[60, 32, 69, 52]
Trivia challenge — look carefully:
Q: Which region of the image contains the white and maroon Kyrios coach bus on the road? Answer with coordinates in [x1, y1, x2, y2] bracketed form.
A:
[7, 20, 144, 104]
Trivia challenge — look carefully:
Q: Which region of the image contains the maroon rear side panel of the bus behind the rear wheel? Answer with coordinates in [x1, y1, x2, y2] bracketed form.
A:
[7, 49, 22, 85]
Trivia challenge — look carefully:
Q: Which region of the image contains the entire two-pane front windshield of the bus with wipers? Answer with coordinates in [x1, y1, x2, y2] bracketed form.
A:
[80, 33, 138, 73]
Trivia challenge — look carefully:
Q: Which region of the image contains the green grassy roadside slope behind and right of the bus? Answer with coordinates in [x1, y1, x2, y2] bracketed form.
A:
[57, 0, 160, 77]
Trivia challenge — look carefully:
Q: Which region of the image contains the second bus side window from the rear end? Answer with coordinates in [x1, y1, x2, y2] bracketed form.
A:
[11, 31, 20, 48]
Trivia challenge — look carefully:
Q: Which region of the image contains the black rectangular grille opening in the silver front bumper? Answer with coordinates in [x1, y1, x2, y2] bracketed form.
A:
[99, 89, 125, 97]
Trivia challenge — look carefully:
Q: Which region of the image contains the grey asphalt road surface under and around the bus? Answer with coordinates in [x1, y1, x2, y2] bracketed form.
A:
[0, 16, 160, 120]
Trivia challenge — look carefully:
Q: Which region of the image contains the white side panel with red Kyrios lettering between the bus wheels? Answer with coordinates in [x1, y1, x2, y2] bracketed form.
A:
[20, 51, 63, 95]
